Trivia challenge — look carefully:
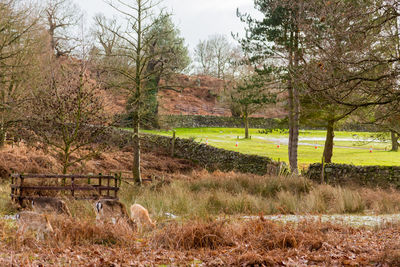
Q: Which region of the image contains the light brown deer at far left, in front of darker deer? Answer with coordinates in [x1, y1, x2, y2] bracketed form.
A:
[16, 211, 54, 240]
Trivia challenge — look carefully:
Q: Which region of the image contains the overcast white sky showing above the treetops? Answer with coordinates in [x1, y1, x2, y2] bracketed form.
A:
[75, 0, 254, 51]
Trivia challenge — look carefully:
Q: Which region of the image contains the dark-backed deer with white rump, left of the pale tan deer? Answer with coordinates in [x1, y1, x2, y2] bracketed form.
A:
[95, 199, 131, 227]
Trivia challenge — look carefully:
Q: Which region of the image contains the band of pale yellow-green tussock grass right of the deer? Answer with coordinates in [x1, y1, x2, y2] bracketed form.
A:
[120, 172, 400, 218]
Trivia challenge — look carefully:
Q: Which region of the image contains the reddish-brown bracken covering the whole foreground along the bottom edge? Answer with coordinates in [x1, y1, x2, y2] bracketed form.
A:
[0, 219, 400, 266]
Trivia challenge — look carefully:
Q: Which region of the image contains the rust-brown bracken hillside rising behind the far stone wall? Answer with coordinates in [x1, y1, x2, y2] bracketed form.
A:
[97, 74, 286, 118]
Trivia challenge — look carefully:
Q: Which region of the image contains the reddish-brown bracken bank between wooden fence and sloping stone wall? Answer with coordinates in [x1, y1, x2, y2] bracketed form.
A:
[0, 144, 198, 178]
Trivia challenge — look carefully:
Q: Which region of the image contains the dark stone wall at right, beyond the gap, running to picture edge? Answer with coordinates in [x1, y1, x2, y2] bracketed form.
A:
[306, 163, 400, 189]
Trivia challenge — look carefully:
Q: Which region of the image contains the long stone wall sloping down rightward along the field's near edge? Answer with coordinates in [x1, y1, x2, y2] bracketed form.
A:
[98, 129, 287, 175]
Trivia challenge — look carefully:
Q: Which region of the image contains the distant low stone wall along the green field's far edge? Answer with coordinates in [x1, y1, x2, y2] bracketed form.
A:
[159, 115, 282, 129]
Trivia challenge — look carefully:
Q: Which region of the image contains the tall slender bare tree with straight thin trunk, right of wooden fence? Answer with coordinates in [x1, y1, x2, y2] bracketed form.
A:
[107, 0, 167, 185]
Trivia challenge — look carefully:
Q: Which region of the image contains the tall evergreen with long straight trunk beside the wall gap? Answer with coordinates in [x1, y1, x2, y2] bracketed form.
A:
[238, 0, 304, 174]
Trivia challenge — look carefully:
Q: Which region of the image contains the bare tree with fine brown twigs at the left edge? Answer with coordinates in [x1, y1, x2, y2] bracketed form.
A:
[0, 0, 42, 147]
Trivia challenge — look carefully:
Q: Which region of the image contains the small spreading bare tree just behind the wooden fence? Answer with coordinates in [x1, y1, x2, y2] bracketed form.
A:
[27, 59, 107, 174]
